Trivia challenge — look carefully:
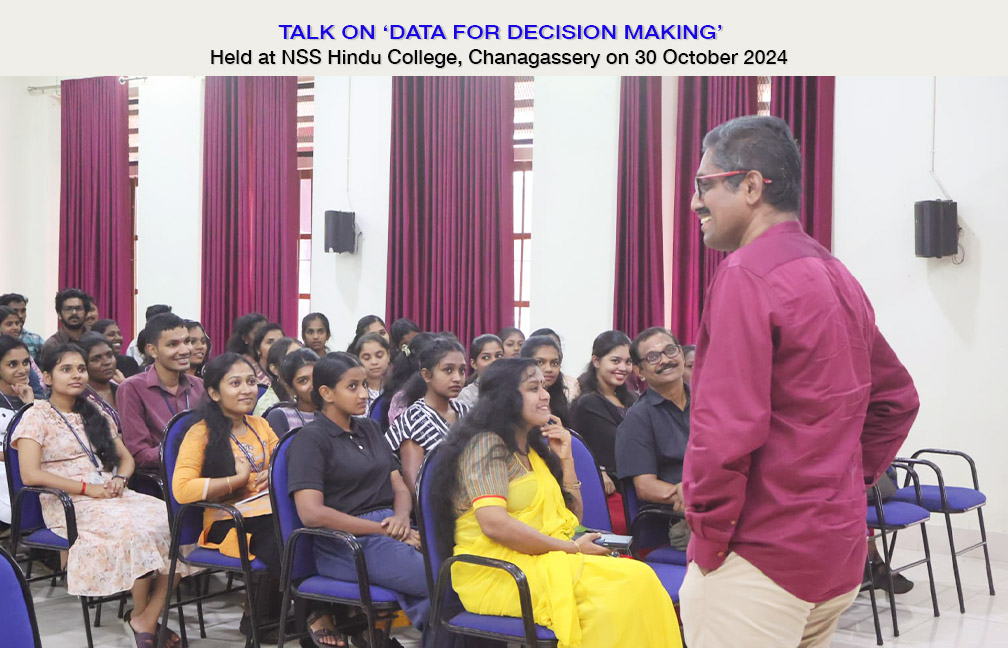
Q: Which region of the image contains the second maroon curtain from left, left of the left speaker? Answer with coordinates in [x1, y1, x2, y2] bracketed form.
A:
[202, 77, 298, 349]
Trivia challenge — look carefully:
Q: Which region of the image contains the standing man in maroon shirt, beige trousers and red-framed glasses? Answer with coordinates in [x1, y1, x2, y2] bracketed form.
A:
[680, 117, 919, 648]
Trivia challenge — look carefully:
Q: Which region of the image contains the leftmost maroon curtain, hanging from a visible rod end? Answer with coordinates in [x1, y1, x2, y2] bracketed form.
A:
[59, 77, 133, 340]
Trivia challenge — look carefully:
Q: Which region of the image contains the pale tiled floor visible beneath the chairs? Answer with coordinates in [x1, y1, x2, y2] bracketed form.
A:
[27, 548, 1008, 648]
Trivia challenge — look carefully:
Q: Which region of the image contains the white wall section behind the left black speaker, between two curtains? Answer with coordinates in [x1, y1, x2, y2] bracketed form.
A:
[311, 77, 392, 350]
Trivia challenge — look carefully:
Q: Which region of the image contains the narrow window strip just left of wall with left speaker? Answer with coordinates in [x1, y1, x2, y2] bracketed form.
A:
[297, 77, 314, 326]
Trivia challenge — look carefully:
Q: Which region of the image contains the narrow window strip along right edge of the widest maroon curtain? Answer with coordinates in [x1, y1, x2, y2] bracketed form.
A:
[514, 77, 535, 335]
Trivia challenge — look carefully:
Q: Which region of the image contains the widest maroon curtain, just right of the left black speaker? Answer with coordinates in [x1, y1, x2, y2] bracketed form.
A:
[386, 77, 514, 344]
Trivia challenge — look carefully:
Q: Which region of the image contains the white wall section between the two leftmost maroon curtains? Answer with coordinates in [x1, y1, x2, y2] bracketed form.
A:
[133, 77, 203, 332]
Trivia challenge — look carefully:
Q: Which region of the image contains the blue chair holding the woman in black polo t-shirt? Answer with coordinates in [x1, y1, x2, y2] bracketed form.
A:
[269, 428, 407, 648]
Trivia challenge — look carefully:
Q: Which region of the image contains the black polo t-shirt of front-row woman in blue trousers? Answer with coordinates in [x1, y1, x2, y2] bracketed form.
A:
[287, 414, 396, 515]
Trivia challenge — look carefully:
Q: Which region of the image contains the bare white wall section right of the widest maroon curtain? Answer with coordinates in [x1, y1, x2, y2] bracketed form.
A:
[529, 77, 620, 375]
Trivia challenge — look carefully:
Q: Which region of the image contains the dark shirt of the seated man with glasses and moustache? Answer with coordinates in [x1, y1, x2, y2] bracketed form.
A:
[616, 387, 689, 484]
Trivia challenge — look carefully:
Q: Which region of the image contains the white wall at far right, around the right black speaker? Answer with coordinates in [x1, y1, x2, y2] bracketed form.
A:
[834, 78, 1008, 533]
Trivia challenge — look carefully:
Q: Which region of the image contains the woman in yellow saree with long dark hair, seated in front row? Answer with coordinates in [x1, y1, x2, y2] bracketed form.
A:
[432, 359, 682, 648]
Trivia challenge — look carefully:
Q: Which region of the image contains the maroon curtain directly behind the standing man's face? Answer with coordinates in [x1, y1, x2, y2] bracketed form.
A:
[671, 77, 757, 344]
